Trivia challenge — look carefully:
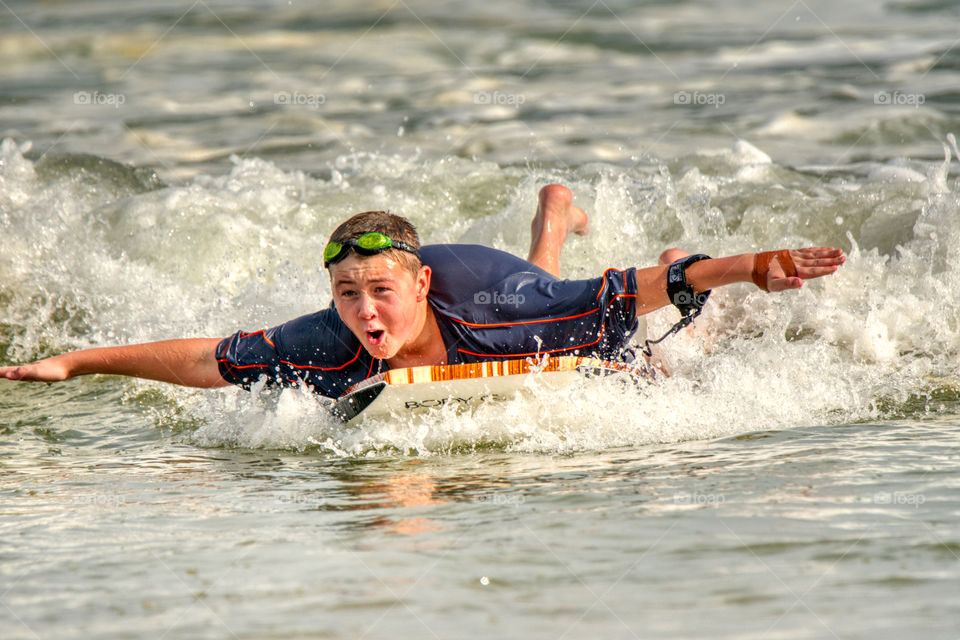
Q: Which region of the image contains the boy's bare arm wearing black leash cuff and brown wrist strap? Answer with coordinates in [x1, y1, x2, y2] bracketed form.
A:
[637, 247, 846, 313]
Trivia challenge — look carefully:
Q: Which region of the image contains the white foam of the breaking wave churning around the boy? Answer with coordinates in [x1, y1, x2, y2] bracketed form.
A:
[0, 142, 960, 455]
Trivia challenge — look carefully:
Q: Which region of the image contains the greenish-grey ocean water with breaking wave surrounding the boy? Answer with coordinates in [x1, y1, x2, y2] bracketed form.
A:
[0, 0, 960, 639]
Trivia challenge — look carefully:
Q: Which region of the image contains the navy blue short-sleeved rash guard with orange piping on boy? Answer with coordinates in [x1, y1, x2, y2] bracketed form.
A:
[217, 245, 638, 398]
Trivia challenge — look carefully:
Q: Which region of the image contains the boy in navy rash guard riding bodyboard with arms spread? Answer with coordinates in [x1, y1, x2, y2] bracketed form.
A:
[0, 185, 845, 397]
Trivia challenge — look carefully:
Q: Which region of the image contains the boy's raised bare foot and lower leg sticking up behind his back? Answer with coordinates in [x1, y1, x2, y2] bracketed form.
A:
[527, 184, 589, 278]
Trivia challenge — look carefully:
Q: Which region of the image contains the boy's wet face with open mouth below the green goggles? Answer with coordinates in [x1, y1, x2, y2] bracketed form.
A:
[330, 252, 430, 360]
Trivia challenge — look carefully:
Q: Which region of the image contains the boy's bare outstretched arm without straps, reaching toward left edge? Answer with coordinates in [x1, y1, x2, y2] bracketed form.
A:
[0, 338, 229, 387]
